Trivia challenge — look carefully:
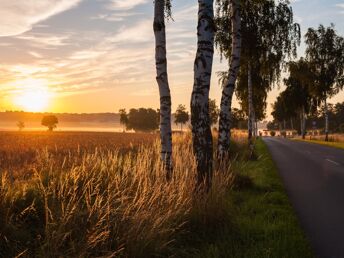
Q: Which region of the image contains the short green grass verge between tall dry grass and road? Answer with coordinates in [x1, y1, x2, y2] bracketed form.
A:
[183, 140, 313, 258]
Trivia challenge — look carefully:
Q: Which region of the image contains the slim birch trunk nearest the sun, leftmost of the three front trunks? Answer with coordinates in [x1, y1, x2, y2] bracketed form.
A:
[153, 0, 172, 175]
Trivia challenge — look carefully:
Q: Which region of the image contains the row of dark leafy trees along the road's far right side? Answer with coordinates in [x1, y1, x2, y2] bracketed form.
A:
[272, 24, 344, 141]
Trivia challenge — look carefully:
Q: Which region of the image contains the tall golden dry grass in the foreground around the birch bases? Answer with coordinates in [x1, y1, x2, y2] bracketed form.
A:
[0, 135, 232, 257]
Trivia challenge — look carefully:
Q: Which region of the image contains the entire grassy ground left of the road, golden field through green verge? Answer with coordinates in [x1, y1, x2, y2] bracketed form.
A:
[0, 132, 311, 258]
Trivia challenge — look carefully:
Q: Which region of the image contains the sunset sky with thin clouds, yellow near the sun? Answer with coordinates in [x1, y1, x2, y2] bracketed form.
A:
[0, 0, 344, 119]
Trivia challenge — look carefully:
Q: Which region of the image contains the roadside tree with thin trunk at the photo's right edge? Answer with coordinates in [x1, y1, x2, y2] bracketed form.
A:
[306, 24, 344, 141]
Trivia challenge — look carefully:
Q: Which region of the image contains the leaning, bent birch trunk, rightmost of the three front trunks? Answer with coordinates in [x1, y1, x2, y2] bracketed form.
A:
[218, 0, 241, 158]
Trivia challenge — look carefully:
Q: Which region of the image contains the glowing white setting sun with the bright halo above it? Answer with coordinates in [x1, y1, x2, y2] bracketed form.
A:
[13, 79, 50, 112]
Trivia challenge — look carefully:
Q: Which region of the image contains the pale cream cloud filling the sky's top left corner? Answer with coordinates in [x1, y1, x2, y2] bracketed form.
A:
[0, 0, 82, 37]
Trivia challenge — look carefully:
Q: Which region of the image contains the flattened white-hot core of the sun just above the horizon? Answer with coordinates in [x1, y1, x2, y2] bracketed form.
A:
[14, 91, 49, 112]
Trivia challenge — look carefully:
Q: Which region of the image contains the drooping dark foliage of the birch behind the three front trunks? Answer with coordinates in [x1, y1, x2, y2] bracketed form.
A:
[215, 0, 301, 120]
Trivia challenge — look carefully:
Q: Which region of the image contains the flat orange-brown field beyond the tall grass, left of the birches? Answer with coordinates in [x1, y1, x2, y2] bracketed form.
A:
[0, 132, 157, 178]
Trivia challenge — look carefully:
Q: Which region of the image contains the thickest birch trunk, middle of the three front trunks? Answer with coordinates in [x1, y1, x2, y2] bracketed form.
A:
[191, 0, 214, 187]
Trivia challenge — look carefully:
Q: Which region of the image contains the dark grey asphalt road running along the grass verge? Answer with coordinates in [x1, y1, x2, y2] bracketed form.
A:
[264, 137, 344, 258]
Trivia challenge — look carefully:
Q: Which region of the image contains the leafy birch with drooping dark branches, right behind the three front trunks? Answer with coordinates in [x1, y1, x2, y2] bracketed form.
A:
[216, 0, 300, 154]
